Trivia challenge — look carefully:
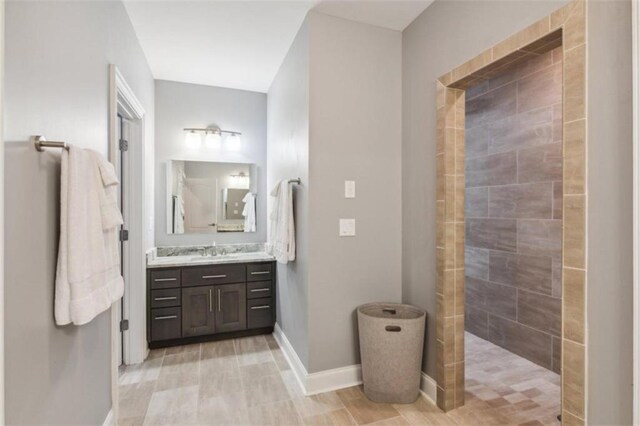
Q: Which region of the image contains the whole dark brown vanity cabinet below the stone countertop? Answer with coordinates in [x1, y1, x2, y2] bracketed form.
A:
[147, 262, 275, 348]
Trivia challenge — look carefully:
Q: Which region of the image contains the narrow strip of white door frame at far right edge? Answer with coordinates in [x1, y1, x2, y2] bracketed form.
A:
[631, 0, 640, 425]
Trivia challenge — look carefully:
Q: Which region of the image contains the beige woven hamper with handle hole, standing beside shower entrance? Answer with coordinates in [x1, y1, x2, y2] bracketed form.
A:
[358, 303, 425, 404]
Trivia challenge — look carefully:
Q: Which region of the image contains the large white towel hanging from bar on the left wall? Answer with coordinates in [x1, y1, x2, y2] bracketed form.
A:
[55, 147, 124, 325]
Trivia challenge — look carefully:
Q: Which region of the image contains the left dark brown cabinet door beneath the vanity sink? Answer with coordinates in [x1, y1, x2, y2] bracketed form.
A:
[182, 286, 215, 337]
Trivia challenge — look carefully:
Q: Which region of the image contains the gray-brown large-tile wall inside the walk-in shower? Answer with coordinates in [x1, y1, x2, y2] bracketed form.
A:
[465, 48, 562, 372]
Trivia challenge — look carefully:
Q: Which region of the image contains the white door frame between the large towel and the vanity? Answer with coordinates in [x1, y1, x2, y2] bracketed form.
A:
[109, 64, 147, 419]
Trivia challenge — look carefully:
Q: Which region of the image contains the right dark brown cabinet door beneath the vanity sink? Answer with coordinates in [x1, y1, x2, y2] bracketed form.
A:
[215, 283, 247, 333]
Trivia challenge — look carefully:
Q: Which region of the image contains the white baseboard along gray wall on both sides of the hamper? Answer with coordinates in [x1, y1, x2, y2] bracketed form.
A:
[273, 323, 437, 404]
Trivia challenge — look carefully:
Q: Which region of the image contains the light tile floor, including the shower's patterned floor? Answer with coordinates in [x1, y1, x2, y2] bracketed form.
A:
[118, 334, 560, 425]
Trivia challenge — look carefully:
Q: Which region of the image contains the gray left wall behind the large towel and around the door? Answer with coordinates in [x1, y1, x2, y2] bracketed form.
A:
[4, 1, 153, 424]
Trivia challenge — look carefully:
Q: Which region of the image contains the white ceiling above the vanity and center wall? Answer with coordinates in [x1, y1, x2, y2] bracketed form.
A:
[124, 0, 433, 92]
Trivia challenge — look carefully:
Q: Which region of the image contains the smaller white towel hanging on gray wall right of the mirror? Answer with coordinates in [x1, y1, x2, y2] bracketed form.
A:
[267, 179, 296, 264]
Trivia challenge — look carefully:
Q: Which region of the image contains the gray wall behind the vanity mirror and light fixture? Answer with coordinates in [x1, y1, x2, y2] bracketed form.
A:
[155, 80, 268, 246]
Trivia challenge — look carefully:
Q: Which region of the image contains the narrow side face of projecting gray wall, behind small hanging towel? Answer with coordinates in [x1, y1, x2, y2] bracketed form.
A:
[267, 20, 309, 370]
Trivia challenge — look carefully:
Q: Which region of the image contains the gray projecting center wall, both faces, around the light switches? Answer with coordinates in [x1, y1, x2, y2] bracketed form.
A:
[268, 12, 402, 373]
